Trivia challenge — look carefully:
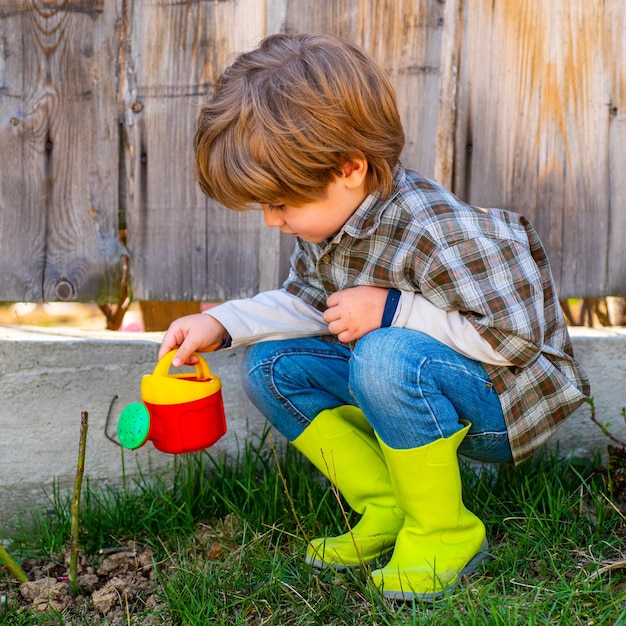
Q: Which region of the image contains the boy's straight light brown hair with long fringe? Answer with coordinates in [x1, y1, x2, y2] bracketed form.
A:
[194, 35, 404, 210]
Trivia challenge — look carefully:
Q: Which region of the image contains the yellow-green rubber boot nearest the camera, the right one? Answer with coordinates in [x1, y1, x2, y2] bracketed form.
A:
[372, 426, 488, 600]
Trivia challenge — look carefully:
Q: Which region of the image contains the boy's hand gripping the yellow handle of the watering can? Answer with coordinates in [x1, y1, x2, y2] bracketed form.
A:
[159, 313, 228, 367]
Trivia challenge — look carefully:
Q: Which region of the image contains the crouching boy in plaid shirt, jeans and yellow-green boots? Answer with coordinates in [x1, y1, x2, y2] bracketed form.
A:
[159, 35, 589, 599]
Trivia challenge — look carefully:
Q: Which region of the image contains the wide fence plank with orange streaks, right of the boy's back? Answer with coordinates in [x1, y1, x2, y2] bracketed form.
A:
[455, 0, 626, 297]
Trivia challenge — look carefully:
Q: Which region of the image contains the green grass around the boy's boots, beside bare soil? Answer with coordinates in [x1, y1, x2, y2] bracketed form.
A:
[0, 428, 626, 626]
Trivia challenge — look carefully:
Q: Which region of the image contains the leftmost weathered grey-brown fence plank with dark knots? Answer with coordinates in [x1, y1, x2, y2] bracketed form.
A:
[0, 0, 122, 302]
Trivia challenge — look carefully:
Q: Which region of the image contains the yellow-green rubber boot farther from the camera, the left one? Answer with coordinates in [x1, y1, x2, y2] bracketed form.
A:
[292, 405, 404, 569]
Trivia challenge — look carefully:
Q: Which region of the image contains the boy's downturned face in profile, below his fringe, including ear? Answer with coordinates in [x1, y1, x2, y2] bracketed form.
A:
[262, 165, 367, 243]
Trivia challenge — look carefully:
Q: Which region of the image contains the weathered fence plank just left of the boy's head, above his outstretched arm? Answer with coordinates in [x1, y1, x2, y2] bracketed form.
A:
[122, 0, 268, 300]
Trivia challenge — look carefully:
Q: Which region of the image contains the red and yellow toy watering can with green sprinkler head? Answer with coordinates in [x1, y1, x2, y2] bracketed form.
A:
[117, 350, 226, 454]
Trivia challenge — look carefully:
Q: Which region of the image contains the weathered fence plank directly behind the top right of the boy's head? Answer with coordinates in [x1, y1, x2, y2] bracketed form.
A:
[286, 0, 458, 184]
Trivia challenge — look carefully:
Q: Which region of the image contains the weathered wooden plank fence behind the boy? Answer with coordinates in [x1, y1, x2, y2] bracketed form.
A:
[0, 0, 626, 303]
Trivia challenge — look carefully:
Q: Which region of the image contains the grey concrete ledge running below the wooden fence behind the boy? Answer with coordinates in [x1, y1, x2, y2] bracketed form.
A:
[0, 326, 626, 528]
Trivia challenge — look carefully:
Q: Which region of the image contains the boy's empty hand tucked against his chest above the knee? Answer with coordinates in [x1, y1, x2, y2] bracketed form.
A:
[324, 285, 389, 343]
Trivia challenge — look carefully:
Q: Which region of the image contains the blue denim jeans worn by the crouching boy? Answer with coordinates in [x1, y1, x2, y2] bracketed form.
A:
[243, 328, 512, 463]
